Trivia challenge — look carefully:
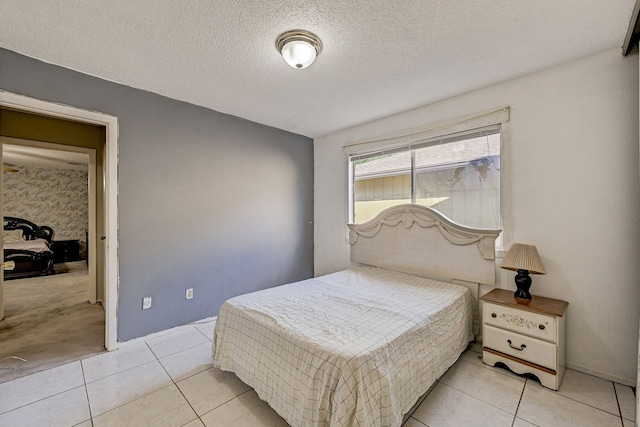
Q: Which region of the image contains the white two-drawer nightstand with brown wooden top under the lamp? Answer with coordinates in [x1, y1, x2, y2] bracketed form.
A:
[480, 289, 569, 390]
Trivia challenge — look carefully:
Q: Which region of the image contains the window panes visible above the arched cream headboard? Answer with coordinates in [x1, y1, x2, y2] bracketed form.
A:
[350, 124, 502, 229]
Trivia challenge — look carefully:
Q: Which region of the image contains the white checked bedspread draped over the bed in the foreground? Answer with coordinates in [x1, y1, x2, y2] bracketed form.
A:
[212, 267, 477, 427]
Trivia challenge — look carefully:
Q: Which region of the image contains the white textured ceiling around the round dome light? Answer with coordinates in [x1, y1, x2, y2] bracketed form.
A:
[0, 0, 635, 137]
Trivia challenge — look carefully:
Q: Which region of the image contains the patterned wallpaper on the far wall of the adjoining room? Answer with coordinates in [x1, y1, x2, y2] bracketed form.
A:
[3, 166, 89, 258]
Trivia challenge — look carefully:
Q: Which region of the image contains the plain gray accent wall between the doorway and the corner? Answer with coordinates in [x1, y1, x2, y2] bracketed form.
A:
[0, 49, 313, 341]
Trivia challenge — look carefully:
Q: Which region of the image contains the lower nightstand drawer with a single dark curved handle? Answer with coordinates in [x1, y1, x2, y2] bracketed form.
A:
[482, 325, 556, 370]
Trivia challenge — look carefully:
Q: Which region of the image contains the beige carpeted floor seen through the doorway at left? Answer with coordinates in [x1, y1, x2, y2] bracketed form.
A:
[0, 261, 105, 383]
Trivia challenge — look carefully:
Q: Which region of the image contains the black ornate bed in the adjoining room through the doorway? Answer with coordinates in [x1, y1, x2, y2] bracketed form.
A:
[3, 216, 55, 280]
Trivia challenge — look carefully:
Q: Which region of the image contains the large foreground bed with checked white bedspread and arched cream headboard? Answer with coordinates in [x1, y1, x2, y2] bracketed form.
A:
[212, 205, 499, 427]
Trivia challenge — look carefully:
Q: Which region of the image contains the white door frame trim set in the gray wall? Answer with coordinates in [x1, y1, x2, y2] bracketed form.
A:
[0, 89, 119, 351]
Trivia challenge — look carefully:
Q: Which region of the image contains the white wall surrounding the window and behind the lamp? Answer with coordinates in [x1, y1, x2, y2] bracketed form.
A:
[314, 50, 640, 385]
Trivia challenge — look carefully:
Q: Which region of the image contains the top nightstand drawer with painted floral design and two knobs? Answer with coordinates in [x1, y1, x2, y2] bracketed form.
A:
[482, 302, 557, 342]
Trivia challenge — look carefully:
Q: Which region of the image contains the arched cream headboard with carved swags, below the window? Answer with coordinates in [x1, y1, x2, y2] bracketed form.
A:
[348, 204, 501, 285]
